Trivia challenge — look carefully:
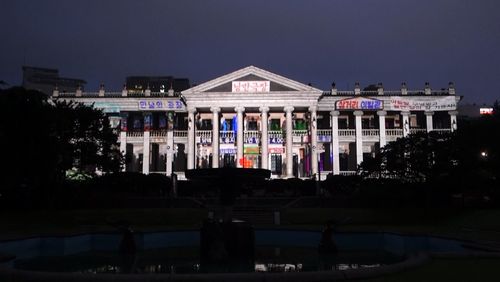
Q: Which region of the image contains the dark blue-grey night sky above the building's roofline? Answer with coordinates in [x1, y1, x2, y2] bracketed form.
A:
[0, 0, 500, 103]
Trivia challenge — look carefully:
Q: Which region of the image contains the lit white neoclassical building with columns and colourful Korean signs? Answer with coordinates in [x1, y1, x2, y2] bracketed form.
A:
[52, 66, 460, 178]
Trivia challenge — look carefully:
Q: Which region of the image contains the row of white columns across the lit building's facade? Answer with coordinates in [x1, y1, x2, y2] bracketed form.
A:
[119, 106, 458, 177]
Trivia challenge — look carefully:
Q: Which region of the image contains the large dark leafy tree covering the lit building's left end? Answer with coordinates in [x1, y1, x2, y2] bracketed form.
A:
[0, 87, 121, 205]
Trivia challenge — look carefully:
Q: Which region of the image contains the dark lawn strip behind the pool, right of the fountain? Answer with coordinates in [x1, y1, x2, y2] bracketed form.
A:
[282, 208, 500, 242]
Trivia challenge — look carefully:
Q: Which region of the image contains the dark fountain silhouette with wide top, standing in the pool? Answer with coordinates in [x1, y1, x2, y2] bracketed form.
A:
[186, 168, 271, 272]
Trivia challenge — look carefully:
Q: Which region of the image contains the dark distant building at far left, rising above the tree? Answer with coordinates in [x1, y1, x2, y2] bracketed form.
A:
[23, 66, 87, 95]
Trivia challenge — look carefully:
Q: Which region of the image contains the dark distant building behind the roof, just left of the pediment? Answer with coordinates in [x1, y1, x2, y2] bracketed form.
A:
[126, 76, 191, 93]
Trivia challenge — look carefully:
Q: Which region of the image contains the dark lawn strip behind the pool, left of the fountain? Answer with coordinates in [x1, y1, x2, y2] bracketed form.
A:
[0, 208, 207, 239]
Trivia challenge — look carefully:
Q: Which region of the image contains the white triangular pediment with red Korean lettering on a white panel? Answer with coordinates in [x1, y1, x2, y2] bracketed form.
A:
[182, 66, 321, 94]
